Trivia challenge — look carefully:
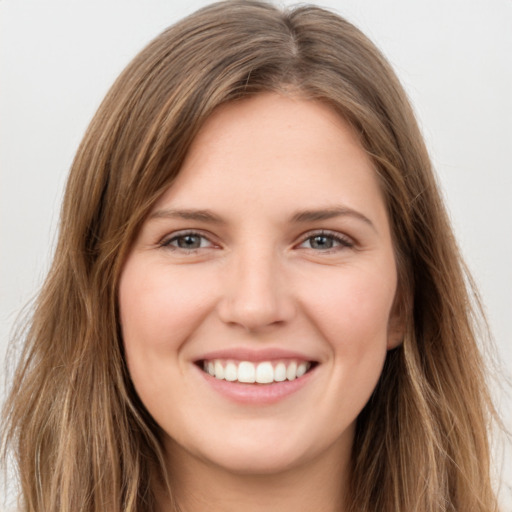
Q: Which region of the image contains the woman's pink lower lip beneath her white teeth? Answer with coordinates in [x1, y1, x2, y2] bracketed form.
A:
[196, 366, 317, 405]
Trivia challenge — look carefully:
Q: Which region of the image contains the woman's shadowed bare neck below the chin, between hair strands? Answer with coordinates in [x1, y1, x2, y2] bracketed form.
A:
[159, 438, 350, 512]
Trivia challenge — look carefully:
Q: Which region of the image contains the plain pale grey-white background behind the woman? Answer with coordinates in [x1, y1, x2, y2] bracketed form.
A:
[0, 0, 512, 510]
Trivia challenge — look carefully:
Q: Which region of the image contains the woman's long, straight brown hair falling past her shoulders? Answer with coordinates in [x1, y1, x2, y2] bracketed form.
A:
[4, 0, 504, 512]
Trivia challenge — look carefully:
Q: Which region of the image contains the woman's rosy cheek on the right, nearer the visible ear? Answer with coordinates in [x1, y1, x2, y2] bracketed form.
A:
[292, 260, 396, 432]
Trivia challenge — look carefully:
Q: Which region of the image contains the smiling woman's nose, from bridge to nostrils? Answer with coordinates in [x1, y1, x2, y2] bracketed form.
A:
[218, 247, 296, 332]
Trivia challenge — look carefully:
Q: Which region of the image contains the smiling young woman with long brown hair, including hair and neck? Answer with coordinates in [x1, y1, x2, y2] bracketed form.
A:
[1, 1, 504, 512]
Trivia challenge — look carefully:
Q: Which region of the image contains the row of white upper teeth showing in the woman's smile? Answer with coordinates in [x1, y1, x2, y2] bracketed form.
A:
[203, 359, 311, 384]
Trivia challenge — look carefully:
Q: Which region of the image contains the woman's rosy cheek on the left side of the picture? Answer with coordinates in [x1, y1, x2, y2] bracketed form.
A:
[118, 258, 218, 424]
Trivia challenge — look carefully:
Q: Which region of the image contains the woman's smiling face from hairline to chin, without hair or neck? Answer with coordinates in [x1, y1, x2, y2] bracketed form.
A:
[119, 93, 401, 474]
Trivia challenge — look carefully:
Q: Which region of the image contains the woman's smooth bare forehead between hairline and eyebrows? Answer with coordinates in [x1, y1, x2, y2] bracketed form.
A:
[155, 93, 386, 232]
